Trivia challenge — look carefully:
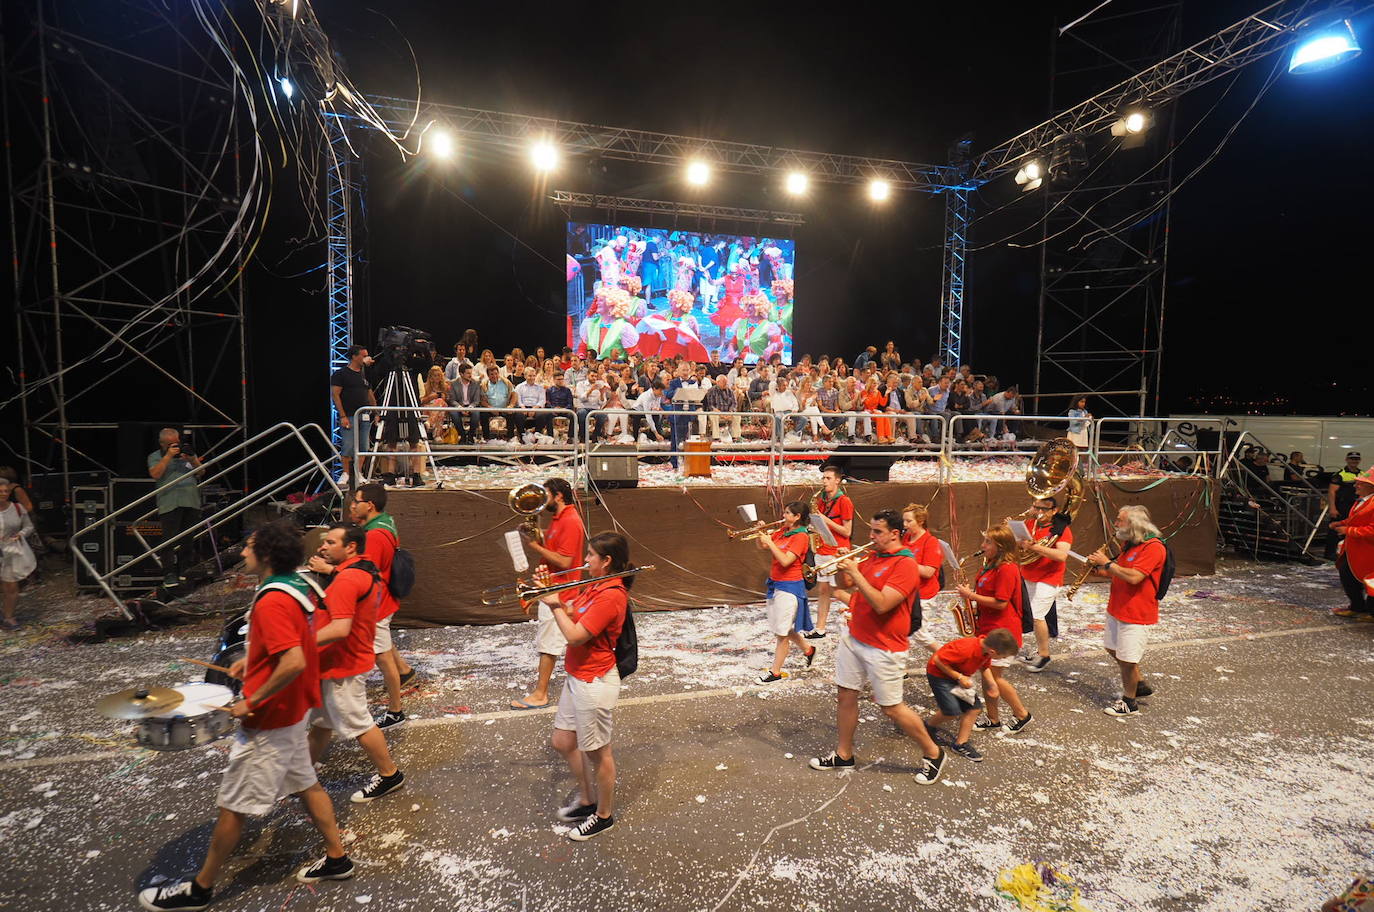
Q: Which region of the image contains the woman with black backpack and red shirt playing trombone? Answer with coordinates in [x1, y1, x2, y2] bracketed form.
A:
[550, 532, 635, 842]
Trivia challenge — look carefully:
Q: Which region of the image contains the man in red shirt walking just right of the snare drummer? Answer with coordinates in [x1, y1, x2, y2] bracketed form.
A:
[309, 522, 405, 805]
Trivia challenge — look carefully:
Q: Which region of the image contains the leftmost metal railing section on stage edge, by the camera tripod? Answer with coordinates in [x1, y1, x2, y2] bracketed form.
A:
[349, 405, 583, 485]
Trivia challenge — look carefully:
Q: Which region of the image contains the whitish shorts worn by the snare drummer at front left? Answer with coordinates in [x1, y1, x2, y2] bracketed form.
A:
[216, 718, 319, 816]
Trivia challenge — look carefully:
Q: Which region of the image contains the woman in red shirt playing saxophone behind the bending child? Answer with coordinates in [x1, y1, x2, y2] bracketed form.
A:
[954, 523, 1031, 761]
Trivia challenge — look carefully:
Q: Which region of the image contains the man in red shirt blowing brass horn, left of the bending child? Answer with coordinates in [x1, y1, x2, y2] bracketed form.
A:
[811, 510, 945, 786]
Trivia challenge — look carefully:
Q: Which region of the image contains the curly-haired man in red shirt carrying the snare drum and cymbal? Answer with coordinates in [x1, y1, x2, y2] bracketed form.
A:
[139, 521, 353, 912]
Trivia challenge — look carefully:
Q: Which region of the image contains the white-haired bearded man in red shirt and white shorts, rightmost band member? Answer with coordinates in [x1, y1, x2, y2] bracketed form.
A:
[1088, 505, 1168, 716]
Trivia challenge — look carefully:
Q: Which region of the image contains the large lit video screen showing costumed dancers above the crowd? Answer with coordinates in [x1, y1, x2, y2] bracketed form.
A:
[567, 223, 797, 364]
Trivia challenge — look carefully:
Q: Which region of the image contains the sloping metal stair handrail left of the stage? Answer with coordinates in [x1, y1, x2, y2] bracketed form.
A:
[69, 422, 344, 618]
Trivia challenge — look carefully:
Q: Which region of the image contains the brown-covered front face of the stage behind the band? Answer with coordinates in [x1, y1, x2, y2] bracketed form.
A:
[387, 475, 1216, 626]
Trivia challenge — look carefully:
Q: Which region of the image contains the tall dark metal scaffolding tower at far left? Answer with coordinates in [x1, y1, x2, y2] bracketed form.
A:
[3, 0, 249, 488]
